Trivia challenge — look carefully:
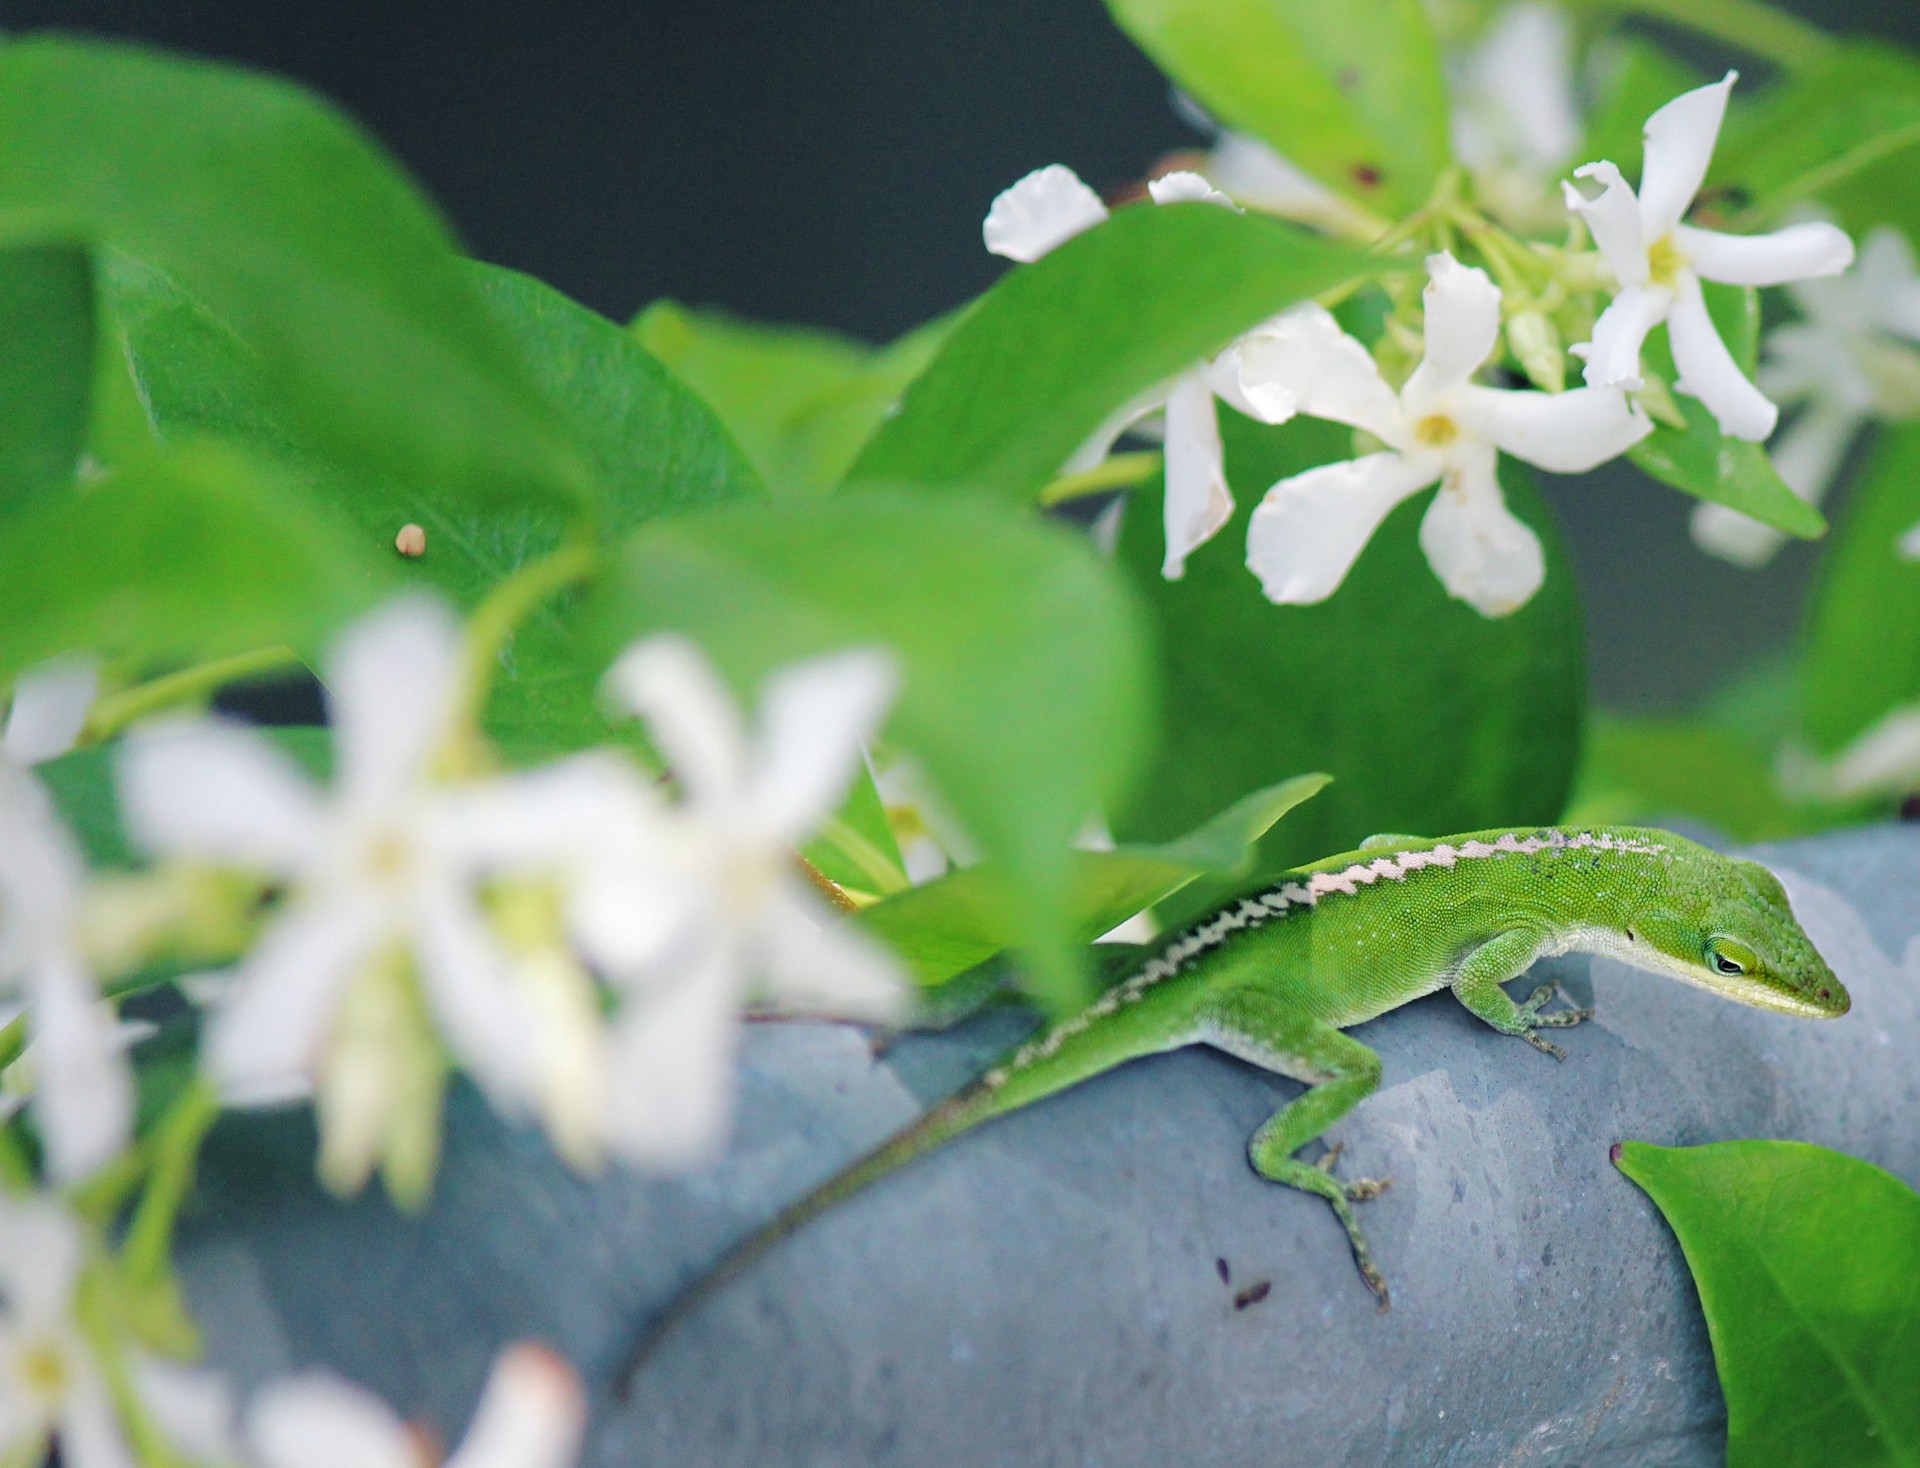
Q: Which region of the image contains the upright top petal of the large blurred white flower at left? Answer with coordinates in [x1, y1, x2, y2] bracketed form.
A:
[324, 595, 463, 808]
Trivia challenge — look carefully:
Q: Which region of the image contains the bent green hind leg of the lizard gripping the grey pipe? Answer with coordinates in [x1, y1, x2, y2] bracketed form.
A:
[1208, 990, 1392, 1311]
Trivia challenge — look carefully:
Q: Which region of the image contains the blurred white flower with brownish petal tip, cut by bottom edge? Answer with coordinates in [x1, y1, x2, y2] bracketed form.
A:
[248, 1345, 586, 1468]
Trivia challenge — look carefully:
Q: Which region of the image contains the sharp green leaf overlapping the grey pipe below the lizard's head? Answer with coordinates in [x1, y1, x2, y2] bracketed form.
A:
[1617, 1142, 1920, 1468]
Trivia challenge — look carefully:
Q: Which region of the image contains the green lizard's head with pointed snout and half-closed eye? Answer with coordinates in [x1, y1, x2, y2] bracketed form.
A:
[1634, 842, 1853, 1019]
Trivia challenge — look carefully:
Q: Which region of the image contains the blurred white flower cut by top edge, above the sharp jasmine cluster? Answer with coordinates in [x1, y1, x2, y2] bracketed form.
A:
[1443, 0, 1582, 228]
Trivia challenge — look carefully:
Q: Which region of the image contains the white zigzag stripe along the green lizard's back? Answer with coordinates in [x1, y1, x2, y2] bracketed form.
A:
[983, 831, 1667, 1090]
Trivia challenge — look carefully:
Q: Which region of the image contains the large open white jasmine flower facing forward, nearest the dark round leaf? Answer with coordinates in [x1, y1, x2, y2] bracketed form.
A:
[1246, 251, 1651, 616]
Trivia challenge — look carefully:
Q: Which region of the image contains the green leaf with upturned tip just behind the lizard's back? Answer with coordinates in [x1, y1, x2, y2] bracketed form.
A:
[854, 775, 1327, 986]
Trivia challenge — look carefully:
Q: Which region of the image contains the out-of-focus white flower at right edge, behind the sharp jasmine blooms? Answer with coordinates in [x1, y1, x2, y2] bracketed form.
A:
[1693, 226, 1920, 566]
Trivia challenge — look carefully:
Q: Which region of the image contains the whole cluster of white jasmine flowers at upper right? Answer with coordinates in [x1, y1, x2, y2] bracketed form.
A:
[985, 67, 1858, 616]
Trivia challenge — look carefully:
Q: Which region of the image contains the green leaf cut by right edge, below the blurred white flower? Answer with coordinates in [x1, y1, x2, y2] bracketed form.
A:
[1805, 424, 1920, 754]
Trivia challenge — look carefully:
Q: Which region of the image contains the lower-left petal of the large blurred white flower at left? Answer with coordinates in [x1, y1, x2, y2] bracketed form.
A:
[202, 892, 386, 1100]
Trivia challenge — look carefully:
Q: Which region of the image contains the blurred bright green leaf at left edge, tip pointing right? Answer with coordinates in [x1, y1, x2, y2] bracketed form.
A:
[0, 443, 386, 679]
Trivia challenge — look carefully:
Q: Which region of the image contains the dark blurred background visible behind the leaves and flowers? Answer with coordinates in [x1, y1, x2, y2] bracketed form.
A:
[0, 0, 1920, 708]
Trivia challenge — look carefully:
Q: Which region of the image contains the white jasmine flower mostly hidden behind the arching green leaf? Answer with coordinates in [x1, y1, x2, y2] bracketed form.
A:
[985, 163, 1294, 581]
